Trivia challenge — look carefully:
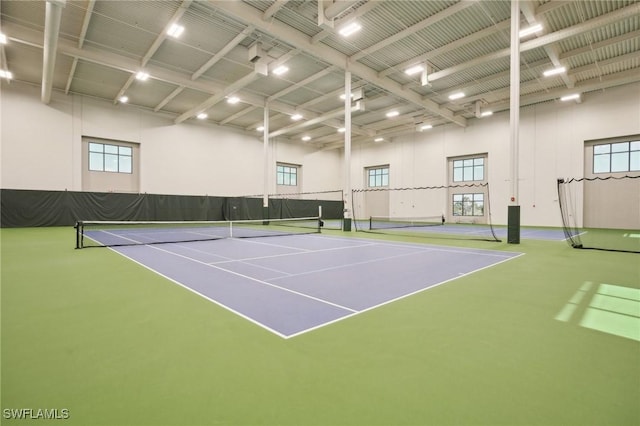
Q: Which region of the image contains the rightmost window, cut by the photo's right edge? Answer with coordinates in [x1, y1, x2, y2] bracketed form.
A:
[593, 141, 640, 173]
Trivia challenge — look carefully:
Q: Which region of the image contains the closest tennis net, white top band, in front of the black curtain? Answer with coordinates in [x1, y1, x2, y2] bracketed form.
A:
[75, 217, 322, 248]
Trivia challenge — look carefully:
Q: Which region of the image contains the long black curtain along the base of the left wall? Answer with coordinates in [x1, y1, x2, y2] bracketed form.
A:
[0, 189, 343, 228]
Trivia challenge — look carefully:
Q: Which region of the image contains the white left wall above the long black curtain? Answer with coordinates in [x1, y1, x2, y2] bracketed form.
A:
[0, 82, 342, 196]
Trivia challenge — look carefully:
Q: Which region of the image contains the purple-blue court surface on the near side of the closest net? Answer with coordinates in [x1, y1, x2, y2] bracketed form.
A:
[109, 234, 520, 338]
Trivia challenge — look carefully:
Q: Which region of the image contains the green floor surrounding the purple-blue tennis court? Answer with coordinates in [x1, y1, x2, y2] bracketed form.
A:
[0, 227, 640, 426]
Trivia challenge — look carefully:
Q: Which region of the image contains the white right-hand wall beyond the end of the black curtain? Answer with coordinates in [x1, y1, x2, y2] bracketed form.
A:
[351, 84, 640, 226]
